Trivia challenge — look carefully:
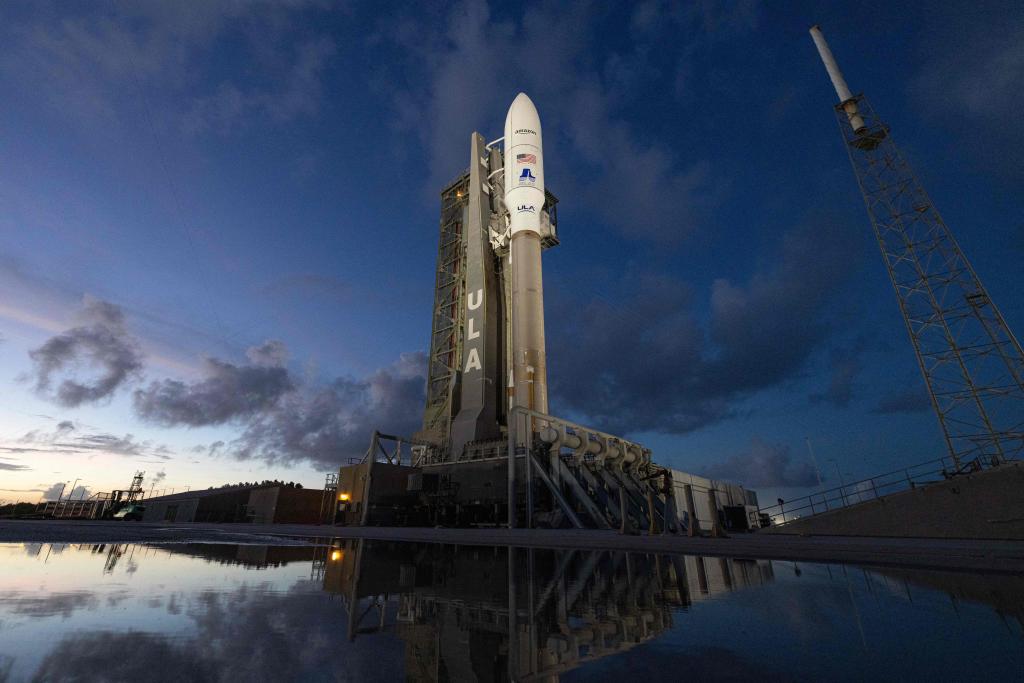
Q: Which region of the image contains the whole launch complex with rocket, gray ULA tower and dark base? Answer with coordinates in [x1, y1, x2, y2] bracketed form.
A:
[335, 93, 758, 532]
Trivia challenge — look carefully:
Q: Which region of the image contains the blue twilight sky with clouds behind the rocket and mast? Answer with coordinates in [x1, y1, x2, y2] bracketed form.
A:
[0, 0, 1024, 500]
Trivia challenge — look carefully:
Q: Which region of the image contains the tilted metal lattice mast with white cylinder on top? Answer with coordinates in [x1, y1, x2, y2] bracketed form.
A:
[811, 28, 1024, 469]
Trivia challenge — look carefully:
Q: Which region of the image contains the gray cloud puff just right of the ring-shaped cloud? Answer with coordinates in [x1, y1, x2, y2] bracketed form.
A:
[133, 341, 294, 427]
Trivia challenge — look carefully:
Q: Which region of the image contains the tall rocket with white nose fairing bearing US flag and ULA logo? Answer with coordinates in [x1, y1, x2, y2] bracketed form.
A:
[505, 92, 548, 414]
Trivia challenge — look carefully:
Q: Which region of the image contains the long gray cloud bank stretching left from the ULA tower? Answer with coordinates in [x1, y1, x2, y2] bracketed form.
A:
[134, 341, 427, 466]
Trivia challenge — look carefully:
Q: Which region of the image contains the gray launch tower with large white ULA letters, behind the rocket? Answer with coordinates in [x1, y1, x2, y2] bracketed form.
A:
[417, 133, 558, 464]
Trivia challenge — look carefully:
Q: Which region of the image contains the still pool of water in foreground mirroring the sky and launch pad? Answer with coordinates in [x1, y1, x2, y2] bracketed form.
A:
[0, 539, 1024, 681]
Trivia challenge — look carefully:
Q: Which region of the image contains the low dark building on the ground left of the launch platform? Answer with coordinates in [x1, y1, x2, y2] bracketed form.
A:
[142, 485, 324, 524]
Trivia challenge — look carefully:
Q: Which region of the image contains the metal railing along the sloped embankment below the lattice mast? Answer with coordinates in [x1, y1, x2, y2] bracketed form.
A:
[759, 457, 984, 526]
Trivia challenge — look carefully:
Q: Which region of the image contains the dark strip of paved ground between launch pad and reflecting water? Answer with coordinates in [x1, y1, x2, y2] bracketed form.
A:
[0, 520, 1024, 572]
